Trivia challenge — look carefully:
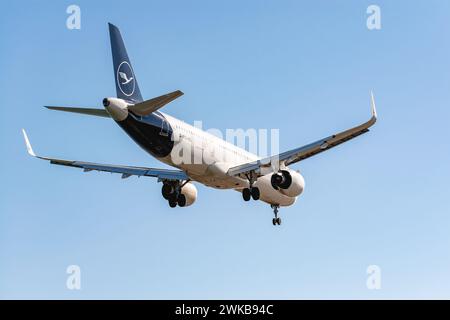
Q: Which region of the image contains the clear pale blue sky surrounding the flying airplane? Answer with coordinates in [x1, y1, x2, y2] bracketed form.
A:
[0, 0, 450, 299]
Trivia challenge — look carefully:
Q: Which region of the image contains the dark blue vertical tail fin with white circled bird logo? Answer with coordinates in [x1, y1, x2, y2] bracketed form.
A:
[108, 23, 143, 103]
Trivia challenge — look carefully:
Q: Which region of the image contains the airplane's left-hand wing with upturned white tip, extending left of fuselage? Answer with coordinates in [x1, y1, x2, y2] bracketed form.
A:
[22, 129, 189, 180]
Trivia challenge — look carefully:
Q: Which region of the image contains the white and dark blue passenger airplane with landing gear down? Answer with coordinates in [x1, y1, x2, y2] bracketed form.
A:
[22, 23, 377, 226]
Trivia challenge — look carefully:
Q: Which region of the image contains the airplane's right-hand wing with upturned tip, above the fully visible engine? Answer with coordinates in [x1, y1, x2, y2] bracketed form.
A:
[227, 94, 377, 178]
